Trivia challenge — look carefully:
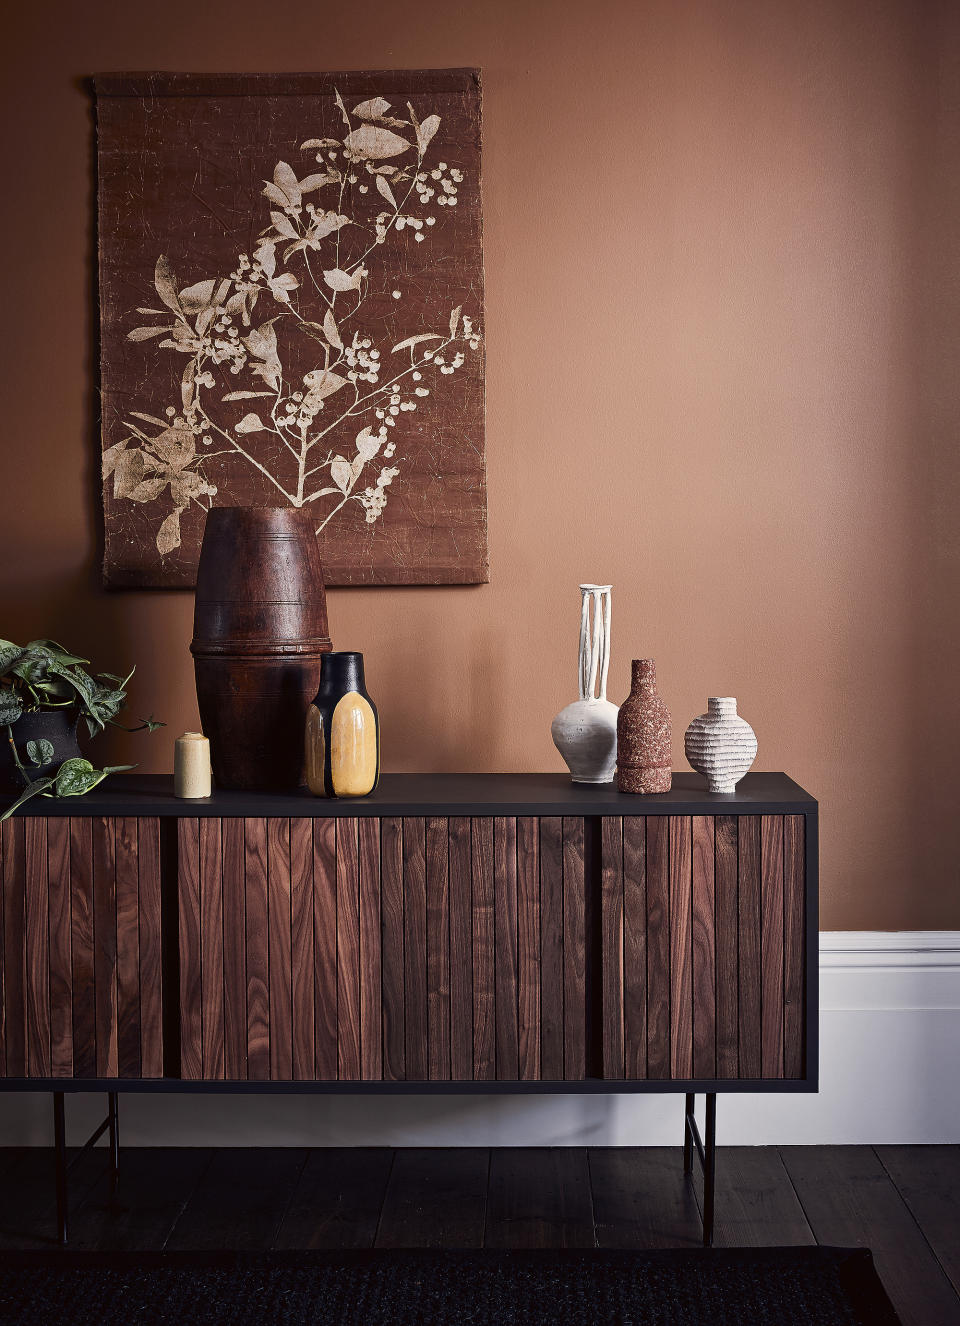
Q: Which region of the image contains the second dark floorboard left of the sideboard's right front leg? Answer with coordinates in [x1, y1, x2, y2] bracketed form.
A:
[485, 1147, 597, 1248]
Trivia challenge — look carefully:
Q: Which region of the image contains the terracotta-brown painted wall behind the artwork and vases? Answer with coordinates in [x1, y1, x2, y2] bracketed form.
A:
[0, 0, 960, 928]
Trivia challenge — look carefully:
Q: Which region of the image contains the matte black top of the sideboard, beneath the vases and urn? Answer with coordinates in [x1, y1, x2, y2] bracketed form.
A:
[0, 773, 817, 818]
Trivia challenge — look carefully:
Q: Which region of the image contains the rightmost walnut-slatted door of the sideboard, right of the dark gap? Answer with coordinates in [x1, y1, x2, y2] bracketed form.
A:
[599, 815, 809, 1081]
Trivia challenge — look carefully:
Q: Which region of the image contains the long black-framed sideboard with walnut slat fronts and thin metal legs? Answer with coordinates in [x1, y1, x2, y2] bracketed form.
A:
[0, 773, 818, 1246]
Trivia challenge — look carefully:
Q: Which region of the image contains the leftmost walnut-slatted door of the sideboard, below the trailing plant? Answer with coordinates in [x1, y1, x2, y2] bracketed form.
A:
[0, 817, 163, 1079]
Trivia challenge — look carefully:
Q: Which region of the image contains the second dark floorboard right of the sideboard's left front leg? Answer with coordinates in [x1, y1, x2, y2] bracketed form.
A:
[165, 1147, 306, 1252]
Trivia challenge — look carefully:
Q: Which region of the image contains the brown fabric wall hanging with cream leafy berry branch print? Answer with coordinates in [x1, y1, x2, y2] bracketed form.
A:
[97, 70, 487, 586]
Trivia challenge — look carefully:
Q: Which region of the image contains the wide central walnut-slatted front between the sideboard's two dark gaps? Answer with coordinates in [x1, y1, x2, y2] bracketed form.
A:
[179, 817, 587, 1082]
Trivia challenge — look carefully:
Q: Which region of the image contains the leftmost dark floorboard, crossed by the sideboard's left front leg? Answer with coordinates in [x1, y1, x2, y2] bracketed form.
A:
[0, 1147, 109, 1248]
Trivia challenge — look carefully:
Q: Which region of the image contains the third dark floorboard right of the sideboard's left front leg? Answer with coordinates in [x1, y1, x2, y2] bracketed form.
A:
[274, 1147, 394, 1248]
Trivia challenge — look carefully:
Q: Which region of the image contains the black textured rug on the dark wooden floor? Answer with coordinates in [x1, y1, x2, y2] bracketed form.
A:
[0, 1248, 898, 1326]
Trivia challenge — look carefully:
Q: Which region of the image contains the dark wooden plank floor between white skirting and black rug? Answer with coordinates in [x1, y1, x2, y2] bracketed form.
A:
[0, 1147, 960, 1326]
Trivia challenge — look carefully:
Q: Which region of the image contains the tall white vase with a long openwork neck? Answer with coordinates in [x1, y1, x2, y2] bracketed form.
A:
[550, 585, 618, 782]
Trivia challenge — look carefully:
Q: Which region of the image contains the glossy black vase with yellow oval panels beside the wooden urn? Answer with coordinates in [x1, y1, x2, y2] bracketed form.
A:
[305, 652, 381, 797]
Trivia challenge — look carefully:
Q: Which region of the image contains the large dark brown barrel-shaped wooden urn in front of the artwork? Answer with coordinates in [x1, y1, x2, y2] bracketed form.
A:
[191, 507, 331, 792]
